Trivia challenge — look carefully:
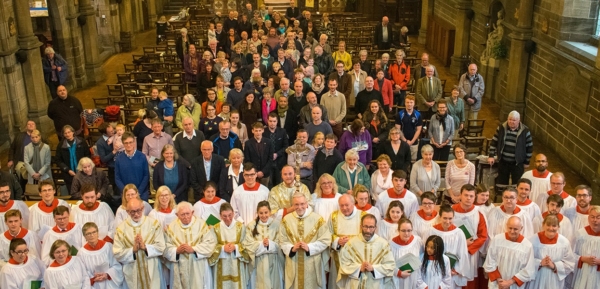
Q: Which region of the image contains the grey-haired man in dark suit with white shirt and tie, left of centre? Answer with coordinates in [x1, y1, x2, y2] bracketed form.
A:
[190, 140, 226, 202]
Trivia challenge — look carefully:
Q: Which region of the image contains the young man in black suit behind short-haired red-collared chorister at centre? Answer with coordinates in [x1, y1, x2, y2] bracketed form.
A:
[244, 122, 273, 186]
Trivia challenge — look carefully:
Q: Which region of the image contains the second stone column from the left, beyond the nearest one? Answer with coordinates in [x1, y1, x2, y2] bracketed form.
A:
[79, 0, 104, 84]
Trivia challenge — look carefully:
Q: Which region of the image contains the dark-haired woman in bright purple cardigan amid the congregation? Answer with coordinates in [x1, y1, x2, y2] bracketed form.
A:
[338, 119, 373, 169]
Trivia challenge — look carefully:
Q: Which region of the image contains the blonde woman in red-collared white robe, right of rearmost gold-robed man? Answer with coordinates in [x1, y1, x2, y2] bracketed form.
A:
[312, 173, 342, 220]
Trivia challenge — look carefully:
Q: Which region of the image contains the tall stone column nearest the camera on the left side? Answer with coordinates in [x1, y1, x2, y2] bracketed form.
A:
[13, 0, 54, 135]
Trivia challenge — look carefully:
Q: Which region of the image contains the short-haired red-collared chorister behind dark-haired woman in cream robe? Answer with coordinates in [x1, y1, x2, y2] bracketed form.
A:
[230, 163, 269, 226]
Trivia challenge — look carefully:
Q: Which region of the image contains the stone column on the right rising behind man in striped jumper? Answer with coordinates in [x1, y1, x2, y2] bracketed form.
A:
[499, 0, 533, 119]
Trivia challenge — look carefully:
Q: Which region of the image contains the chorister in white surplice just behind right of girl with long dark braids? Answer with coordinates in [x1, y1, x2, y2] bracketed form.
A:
[425, 205, 472, 288]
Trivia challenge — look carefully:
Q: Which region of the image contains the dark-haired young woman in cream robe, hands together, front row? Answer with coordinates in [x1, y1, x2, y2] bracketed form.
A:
[243, 201, 284, 288]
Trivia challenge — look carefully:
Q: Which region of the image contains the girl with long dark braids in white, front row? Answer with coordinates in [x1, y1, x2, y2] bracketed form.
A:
[421, 235, 454, 288]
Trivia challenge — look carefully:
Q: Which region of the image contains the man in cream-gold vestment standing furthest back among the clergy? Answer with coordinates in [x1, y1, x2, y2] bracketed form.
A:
[269, 165, 314, 220]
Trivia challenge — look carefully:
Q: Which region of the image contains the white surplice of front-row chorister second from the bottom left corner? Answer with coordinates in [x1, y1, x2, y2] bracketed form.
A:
[44, 256, 92, 289]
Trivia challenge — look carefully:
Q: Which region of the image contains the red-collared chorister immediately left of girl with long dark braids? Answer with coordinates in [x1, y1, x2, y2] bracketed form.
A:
[389, 218, 426, 289]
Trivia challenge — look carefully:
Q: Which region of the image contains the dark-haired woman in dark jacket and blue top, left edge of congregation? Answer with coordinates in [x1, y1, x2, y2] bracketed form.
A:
[55, 125, 91, 194]
